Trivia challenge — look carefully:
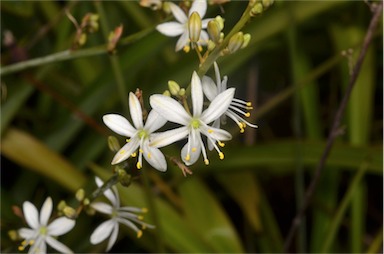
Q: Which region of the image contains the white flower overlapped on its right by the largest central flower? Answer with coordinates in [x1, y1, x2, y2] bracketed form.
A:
[103, 92, 167, 171]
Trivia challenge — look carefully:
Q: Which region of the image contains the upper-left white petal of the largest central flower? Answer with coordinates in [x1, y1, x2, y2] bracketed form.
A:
[149, 94, 191, 125]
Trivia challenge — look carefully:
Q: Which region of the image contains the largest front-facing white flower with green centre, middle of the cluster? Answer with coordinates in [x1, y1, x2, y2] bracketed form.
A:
[150, 72, 235, 165]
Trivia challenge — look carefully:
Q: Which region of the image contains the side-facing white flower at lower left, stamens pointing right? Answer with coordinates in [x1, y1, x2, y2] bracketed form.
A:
[91, 177, 154, 251]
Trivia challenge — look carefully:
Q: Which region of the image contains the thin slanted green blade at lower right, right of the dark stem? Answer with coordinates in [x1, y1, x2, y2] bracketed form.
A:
[321, 161, 369, 253]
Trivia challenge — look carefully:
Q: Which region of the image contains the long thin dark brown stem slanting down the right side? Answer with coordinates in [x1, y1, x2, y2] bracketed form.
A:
[284, 2, 383, 252]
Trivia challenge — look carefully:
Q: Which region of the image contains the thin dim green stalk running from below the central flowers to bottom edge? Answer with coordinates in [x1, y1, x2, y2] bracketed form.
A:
[141, 168, 165, 253]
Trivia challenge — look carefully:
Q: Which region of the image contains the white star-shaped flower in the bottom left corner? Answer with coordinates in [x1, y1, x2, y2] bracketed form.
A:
[18, 197, 75, 253]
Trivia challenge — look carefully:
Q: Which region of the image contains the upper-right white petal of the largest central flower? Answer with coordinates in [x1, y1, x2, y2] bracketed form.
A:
[200, 88, 235, 124]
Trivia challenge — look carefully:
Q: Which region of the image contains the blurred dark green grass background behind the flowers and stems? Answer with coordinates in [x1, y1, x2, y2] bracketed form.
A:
[1, 1, 383, 253]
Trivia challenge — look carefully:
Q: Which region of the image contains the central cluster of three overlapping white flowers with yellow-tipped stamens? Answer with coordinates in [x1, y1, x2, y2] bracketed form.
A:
[103, 63, 257, 171]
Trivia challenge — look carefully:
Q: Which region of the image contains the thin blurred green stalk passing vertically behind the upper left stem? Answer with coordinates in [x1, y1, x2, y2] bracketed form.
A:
[95, 1, 129, 113]
